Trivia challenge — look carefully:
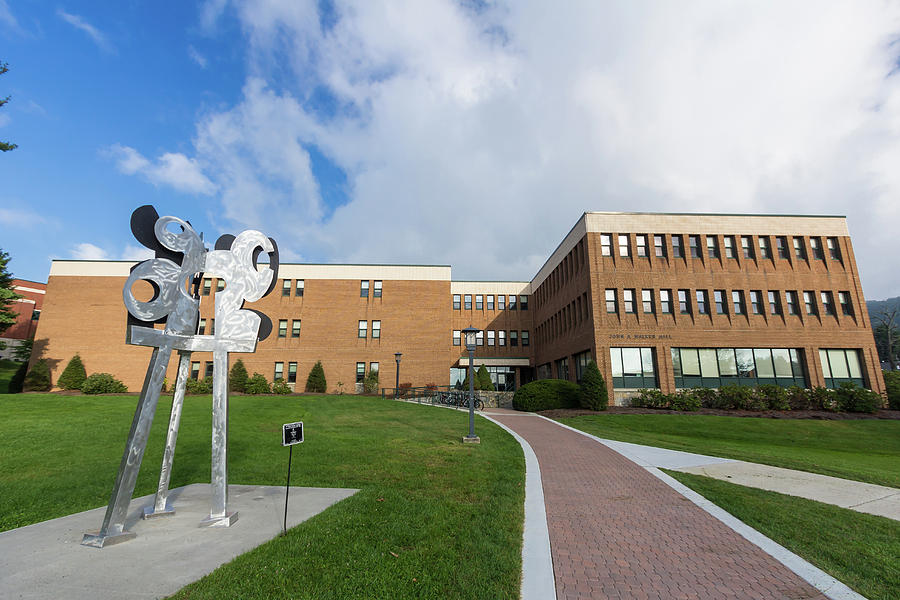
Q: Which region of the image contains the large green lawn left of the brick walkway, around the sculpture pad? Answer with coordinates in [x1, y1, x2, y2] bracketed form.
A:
[0, 394, 524, 599]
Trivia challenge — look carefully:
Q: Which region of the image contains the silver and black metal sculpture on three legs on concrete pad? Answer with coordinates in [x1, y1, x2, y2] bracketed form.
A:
[81, 206, 278, 548]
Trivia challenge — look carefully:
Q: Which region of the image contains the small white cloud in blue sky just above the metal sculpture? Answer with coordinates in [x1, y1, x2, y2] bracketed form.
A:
[106, 144, 215, 195]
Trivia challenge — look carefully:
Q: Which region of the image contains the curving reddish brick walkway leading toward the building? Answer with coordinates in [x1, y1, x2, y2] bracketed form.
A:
[492, 414, 826, 600]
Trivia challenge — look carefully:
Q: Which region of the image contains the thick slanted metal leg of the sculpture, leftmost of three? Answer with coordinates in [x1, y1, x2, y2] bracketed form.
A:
[81, 346, 172, 548]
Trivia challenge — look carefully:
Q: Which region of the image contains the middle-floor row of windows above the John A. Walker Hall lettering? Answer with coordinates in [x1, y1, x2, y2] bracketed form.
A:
[605, 288, 854, 317]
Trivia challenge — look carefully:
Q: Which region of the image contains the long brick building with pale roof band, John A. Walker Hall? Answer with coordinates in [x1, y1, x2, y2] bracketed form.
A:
[29, 212, 884, 401]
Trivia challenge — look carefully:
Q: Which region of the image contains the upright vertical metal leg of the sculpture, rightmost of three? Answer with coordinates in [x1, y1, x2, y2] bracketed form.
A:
[200, 350, 238, 527]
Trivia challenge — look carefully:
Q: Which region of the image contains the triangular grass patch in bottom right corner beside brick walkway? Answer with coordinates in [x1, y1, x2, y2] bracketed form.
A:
[666, 471, 900, 600]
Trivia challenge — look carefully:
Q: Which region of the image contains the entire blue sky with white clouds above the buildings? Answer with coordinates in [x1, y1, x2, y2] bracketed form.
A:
[0, 0, 900, 300]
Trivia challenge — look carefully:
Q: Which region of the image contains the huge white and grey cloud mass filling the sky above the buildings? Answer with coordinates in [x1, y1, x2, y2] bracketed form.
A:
[178, 0, 900, 298]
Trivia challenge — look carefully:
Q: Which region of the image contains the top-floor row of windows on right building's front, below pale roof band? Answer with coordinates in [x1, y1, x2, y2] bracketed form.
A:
[600, 233, 841, 261]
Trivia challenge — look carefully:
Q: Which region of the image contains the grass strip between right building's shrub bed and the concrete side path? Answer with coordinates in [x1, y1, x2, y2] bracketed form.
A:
[558, 414, 900, 487]
